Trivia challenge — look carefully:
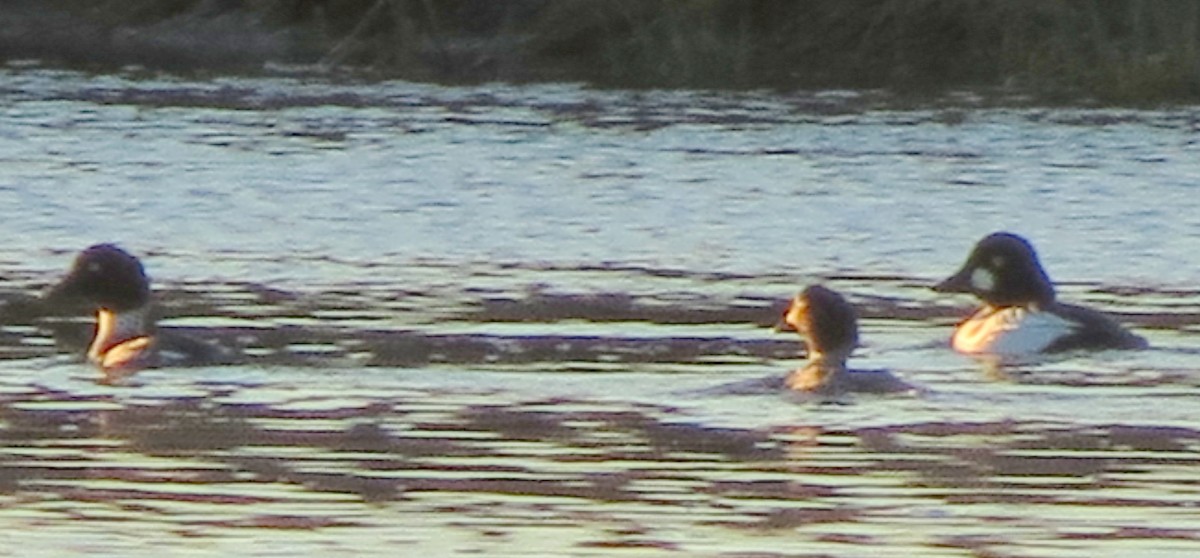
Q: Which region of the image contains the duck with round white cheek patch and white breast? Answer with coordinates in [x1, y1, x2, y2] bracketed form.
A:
[934, 232, 1148, 360]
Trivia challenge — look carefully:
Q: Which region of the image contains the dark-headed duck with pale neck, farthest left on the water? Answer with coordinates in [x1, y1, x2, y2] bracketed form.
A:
[43, 244, 232, 377]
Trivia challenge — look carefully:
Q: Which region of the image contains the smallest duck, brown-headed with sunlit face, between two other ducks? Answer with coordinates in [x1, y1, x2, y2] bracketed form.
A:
[775, 284, 914, 395]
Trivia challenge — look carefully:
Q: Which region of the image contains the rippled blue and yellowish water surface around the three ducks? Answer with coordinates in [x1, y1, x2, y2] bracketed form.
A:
[0, 68, 1200, 557]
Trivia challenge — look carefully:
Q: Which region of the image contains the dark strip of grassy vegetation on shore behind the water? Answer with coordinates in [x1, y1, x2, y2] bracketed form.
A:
[0, 0, 1200, 103]
